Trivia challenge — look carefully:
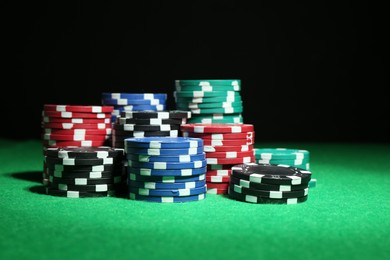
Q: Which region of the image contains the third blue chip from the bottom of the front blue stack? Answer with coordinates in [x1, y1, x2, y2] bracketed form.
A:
[128, 180, 206, 190]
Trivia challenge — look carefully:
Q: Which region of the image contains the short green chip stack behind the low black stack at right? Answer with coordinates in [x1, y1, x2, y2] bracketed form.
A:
[255, 148, 317, 188]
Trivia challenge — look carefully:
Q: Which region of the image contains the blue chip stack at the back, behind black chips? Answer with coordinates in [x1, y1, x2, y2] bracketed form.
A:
[102, 92, 167, 122]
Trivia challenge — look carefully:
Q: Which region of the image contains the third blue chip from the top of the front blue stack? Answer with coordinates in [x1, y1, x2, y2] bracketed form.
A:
[126, 153, 206, 162]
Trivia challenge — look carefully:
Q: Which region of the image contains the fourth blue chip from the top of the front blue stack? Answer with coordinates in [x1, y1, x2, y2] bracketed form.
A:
[127, 159, 207, 170]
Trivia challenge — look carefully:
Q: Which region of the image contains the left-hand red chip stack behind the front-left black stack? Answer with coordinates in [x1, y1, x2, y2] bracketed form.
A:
[41, 104, 114, 185]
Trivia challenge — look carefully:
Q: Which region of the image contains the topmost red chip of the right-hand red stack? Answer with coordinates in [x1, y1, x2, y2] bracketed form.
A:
[181, 123, 254, 134]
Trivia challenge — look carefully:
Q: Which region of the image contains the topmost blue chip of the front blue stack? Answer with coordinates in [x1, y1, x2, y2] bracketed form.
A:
[125, 137, 203, 149]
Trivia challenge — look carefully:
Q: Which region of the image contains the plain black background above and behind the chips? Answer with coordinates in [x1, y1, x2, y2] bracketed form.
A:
[0, 0, 390, 142]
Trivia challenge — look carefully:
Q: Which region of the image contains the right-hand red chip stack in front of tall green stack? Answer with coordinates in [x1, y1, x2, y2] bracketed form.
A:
[181, 123, 255, 194]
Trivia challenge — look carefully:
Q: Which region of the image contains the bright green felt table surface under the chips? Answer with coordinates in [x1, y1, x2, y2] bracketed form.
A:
[0, 139, 390, 260]
